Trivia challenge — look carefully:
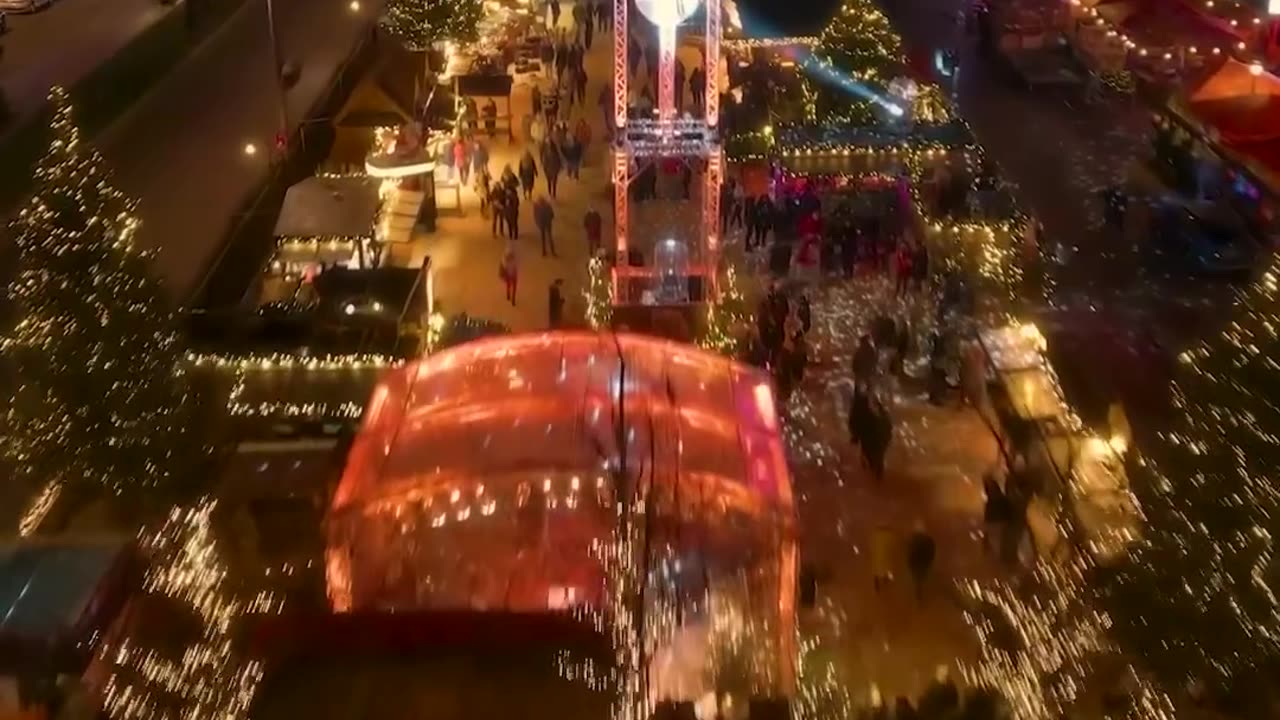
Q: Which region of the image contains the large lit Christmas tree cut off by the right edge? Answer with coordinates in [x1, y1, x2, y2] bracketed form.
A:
[1107, 283, 1280, 691]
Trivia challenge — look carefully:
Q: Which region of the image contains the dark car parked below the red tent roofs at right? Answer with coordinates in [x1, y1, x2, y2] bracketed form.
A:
[1152, 204, 1261, 275]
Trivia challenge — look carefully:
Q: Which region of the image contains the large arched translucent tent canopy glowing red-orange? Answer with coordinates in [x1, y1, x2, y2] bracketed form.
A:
[328, 332, 796, 696]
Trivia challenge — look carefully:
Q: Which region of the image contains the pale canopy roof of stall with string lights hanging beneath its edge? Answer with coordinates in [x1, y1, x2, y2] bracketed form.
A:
[274, 176, 381, 238]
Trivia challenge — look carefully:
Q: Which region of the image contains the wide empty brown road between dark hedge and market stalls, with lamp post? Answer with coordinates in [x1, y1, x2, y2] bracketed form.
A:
[94, 0, 381, 301]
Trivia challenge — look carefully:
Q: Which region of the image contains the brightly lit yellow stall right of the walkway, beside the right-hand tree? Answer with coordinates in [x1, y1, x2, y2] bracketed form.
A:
[978, 324, 1142, 564]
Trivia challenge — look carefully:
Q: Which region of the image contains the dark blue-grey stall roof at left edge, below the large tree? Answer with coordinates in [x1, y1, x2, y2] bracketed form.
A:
[0, 539, 131, 670]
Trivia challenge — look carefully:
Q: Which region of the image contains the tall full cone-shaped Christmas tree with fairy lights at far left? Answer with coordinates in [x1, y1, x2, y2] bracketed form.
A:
[0, 87, 191, 507]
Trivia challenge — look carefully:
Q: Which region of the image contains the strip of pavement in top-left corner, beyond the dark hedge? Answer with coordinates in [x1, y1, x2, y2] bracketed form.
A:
[0, 0, 168, 127]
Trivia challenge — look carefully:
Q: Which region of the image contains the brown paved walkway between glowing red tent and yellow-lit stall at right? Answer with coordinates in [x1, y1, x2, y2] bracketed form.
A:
[773, 275, 1006, 702]
